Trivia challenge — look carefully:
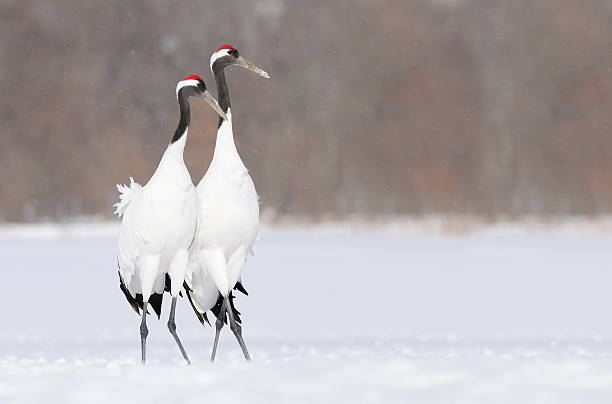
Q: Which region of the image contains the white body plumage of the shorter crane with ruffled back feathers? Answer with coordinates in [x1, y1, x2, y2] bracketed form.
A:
[115, 132, 197, 301]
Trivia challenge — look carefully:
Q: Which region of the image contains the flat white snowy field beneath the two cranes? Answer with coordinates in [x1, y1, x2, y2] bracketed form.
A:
[0, 224, 612, 404]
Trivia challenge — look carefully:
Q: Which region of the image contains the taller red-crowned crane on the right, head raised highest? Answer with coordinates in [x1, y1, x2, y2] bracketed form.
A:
[186, 45, 270, 362]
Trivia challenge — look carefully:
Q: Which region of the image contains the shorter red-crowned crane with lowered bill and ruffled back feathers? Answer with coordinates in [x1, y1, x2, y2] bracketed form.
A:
[115, 75, 227, 363]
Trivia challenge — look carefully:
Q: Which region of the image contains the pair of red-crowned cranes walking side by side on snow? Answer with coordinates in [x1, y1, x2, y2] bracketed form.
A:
[115, 45, 270, 363]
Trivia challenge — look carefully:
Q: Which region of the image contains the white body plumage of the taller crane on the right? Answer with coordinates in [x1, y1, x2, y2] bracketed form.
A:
[190, 109, 259, 313]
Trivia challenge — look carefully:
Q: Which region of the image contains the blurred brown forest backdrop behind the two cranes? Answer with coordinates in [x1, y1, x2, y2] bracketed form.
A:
[0, 0, 612, 221]
